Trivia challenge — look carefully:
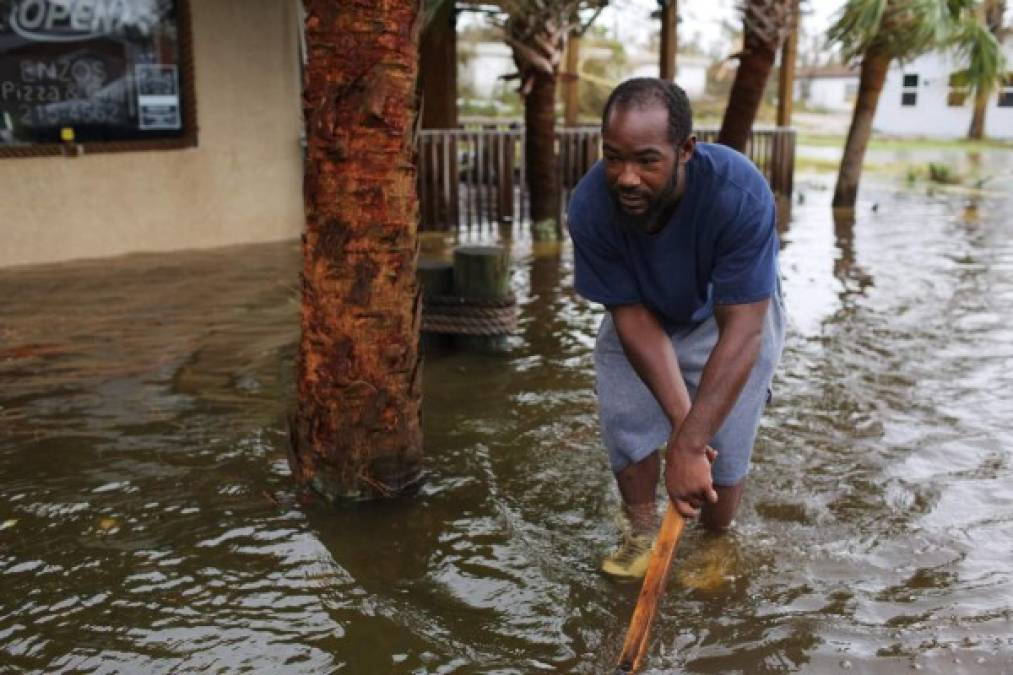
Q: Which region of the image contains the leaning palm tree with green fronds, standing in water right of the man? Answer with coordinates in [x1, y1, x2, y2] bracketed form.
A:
[827, 0, 996, 208]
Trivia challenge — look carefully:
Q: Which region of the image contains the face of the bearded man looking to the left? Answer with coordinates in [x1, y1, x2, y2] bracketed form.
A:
[603, 105, 695, 232]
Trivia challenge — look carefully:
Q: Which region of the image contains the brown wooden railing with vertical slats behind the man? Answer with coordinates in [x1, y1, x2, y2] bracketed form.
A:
[418, 125, 795, 230]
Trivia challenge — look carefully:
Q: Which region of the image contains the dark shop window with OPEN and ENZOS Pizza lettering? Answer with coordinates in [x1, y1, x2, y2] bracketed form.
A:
[0, 0, 197, 157]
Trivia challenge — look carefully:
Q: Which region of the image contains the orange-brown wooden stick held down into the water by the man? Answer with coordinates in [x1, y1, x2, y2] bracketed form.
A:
[615, 501, 686, 675]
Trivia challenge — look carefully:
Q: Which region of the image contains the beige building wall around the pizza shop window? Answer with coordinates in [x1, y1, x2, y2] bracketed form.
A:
[0, 0, 303, 267]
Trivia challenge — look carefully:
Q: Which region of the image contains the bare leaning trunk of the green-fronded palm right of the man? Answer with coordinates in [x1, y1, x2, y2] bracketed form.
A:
[834, 51, 890, 208]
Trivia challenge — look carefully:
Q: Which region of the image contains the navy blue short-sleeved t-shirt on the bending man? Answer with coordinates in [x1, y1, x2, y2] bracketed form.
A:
[567, 143, 779, 326]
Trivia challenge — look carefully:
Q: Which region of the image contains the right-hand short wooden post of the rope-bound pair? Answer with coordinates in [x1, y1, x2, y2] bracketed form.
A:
[454, 246, 510, 352]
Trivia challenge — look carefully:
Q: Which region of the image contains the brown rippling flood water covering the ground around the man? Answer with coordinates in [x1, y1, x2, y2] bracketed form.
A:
[0, 164, 1013, 673]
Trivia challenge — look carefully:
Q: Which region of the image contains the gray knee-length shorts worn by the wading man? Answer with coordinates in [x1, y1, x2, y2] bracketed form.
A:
[595, 295, 784, 485]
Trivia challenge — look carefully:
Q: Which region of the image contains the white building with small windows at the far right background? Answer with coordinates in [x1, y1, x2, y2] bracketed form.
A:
[873, 40, 1013, 139]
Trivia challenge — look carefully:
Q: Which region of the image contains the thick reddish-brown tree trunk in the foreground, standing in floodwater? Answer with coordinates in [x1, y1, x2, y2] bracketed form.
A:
[289, 0, 422, 500]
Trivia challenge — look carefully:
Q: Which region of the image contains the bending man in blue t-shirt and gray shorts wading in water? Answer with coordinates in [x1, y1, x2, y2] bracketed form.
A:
[567, 78, 784, 578]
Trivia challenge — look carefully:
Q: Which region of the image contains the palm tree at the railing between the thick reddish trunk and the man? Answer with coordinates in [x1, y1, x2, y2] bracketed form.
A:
[494, 0, 607, 231]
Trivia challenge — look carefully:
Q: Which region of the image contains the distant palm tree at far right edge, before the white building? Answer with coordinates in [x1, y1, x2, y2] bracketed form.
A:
[956, 0, 1006, 141]
